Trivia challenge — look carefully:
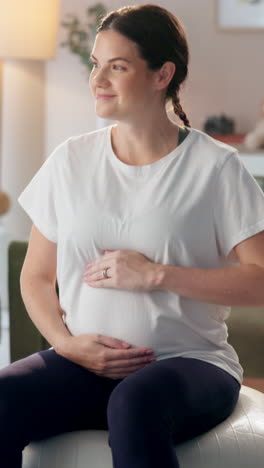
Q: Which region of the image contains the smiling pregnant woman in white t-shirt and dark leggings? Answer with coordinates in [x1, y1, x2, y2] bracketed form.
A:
[0, 5, 264, 468]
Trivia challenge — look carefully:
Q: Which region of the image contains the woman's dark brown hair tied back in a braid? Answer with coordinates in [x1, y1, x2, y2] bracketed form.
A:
[97, 4, 190, 127]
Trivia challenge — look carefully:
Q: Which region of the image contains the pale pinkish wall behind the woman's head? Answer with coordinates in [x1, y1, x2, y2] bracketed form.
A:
[46, 0, 264, 155]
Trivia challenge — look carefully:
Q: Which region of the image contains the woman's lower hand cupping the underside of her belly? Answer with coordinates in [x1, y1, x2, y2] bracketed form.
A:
[57, 333, 156, 379]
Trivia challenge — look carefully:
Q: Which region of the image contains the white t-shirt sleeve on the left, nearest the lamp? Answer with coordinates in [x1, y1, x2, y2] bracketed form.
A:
[18, 144, 65, 242]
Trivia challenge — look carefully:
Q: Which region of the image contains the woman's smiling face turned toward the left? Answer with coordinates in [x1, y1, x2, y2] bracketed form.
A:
[89, 30, 161, 121]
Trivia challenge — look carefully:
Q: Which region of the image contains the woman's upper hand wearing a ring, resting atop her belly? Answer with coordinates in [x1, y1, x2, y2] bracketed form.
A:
[83, 250, 161, 291]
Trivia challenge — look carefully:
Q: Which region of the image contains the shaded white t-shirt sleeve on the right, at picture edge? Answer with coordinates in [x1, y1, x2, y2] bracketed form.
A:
[213, 152, 264, 259]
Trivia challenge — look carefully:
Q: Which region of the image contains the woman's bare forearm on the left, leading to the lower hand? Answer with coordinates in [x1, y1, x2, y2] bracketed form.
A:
[20, 277, 71, 352]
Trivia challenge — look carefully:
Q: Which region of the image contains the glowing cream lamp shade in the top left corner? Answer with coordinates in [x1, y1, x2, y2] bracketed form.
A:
[0, 0, 59, 60]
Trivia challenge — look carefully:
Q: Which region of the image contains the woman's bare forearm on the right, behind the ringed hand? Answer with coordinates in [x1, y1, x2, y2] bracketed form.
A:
[152, 265, 264, 306]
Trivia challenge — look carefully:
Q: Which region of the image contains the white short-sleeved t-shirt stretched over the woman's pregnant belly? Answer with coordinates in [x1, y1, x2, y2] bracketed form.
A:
[18, 126, 264, 382]
